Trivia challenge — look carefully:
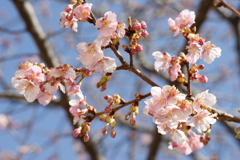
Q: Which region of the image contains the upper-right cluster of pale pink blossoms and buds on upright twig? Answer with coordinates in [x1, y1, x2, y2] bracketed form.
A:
[152, 10, 221, 84]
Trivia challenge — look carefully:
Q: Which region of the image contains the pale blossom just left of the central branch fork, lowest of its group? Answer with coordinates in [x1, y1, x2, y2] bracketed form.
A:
[89, 57, 117, 73]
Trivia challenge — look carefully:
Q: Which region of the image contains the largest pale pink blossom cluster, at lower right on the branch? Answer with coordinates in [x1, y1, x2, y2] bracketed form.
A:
[143, 85, 216, 154]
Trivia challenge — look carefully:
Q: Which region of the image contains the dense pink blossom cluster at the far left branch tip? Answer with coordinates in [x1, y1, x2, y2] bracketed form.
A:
[12, 62, 82, 106]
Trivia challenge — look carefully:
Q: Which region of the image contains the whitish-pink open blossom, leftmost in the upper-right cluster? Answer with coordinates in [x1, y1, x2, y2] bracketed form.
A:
[152, 51, 172, 71]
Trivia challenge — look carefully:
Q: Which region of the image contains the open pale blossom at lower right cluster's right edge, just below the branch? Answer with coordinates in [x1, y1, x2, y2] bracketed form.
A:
[187, 110, 217, 133]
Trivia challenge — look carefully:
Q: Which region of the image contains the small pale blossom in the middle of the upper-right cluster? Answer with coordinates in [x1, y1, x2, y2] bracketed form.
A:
[186, 43, 201, 64]
